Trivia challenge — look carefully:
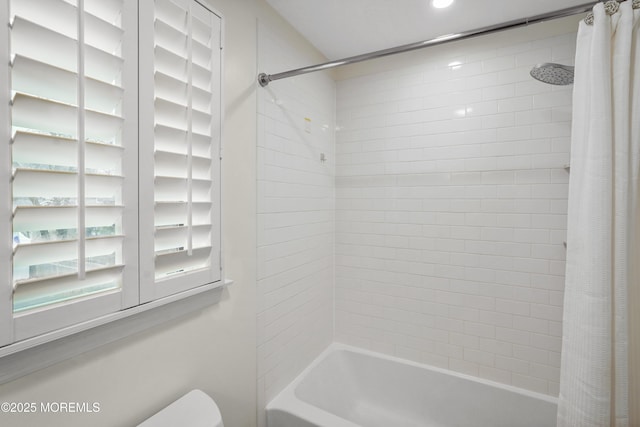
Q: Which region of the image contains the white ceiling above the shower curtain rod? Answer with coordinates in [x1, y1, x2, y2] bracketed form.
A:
[267, 0, 588, 60]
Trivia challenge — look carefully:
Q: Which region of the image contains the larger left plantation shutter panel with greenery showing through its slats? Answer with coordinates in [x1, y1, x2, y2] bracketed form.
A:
[2, 0, 138, 340]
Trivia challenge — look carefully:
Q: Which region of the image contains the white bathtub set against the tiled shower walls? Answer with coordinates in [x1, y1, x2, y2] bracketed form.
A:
[266, 344, 557, 427]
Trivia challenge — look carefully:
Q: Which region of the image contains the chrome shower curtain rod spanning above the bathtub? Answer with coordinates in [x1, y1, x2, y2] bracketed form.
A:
[258, 1, 600, 87]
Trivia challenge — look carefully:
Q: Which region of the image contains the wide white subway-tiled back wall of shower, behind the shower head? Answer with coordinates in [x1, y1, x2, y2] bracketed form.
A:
[335, 25, 576, 395]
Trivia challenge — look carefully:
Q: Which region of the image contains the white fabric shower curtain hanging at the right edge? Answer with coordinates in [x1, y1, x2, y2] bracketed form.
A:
[558, 0, 640, 427]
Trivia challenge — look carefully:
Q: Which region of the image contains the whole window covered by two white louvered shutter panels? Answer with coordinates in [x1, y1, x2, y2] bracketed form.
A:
[0, 0, 222, 352]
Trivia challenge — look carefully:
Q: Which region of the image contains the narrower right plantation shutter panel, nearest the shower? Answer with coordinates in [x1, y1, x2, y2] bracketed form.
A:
[141, 0, 221, 301]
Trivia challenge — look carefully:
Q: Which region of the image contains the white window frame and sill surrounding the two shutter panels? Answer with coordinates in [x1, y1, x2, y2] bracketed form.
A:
[0, 0, 226, 374]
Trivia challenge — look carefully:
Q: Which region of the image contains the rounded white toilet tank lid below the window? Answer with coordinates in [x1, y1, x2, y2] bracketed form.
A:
[138, 390, 222, 427]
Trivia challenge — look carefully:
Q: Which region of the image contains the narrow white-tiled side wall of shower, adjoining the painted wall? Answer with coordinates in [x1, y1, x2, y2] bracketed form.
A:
[256, 25, 335, 426]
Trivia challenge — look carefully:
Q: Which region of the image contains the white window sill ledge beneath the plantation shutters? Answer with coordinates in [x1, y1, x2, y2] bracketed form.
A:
[0, 280, 233, 384]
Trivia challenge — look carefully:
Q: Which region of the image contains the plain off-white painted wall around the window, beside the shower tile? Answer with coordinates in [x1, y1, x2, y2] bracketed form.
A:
[0, 0, 322, 427]
